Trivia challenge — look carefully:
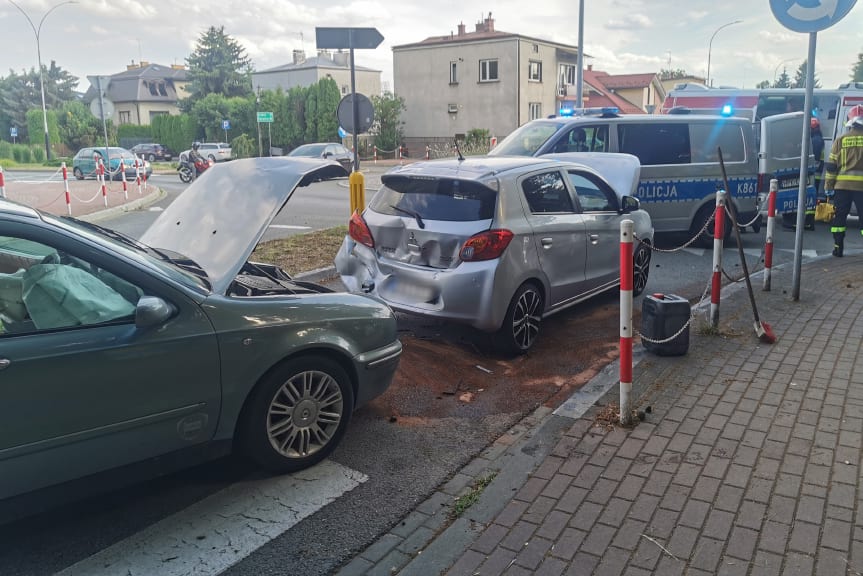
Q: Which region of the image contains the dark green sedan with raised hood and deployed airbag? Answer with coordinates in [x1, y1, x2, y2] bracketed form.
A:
[0, 158, 402, 501]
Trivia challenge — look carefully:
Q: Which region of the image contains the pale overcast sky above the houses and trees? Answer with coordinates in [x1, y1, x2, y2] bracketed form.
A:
[0, 0, 863, 91]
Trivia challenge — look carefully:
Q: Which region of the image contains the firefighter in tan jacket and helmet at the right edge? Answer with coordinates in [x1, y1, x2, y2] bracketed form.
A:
[824, 105, 863, 257]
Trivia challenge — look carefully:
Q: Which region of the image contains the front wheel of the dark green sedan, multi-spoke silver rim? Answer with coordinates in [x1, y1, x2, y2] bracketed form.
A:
[239, 356, 354, 474]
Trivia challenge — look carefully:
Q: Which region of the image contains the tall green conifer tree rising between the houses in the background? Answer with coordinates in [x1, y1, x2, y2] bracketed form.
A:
[187, 26, 252, 111]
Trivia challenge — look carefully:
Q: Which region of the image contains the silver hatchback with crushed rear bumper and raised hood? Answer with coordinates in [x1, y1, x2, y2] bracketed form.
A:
[335, 153, 653, 354]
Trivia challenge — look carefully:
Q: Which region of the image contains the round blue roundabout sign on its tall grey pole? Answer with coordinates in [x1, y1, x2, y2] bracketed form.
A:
[770, 0, 857, 301]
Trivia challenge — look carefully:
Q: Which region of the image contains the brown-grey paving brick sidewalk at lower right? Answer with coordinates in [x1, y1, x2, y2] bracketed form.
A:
[341, 254, 863, 576]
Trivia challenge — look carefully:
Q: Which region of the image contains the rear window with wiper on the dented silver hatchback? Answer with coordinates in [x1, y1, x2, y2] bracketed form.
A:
[371, 176, 497, 222]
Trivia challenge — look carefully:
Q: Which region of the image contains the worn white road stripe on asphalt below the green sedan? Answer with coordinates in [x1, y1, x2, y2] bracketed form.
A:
[55, 460, 368, 576]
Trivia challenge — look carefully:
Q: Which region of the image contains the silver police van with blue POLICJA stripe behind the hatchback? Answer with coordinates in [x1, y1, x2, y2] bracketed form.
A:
[489, 109, 776, 247]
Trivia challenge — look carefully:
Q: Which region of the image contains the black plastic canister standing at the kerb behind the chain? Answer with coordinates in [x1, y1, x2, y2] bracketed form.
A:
[641, 293, 691, 356]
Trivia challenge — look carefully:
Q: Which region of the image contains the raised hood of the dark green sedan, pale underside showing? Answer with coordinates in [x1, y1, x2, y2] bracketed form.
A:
[141, 157, 347, 294]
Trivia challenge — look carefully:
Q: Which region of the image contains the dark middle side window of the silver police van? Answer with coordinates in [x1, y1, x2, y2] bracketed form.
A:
[617, 122, 691, 166]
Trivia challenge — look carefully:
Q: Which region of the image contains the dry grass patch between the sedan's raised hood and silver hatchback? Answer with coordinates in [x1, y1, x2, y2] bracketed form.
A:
[251, 226, 348, 275]
